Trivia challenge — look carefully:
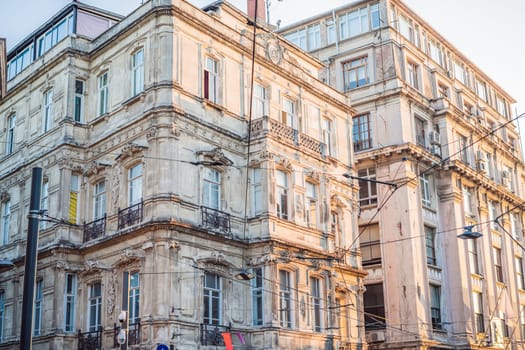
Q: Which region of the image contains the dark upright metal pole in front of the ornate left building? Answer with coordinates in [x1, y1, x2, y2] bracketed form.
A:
[20, 167, 42, 350]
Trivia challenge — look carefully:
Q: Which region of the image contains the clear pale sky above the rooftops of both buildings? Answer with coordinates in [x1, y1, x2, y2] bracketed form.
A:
[0, 0, 525, 123]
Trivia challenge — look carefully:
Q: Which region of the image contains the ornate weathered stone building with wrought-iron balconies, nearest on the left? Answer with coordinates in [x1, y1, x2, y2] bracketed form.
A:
[0, 0, 366, 350]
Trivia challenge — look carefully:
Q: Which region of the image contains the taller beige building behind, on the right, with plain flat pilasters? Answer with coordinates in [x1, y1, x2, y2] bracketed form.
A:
[279, 0, 525, 349]
